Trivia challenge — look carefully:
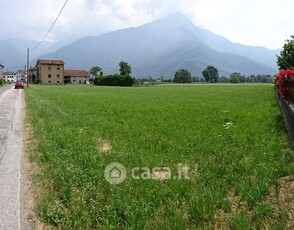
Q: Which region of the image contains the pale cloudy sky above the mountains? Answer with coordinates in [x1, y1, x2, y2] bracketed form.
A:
[0, 0, 294, 49]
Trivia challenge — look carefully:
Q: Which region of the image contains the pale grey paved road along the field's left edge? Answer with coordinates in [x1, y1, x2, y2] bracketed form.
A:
[0, 84, 23, 230]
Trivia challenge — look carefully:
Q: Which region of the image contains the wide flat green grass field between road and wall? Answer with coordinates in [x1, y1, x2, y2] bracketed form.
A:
[25, 84, 293, 229]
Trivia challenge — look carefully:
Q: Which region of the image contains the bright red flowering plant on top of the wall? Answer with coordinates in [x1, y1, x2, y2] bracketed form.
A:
[274, 69, 294, 98]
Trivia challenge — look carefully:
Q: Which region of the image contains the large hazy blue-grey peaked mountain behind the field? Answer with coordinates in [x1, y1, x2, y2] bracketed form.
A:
[31, 13, 278, 77]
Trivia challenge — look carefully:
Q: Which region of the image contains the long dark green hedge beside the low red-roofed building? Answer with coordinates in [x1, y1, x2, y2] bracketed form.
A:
[94, 74, 135, 86]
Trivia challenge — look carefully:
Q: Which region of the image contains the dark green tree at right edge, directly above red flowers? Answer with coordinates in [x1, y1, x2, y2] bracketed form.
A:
[277, 35, 294, 70]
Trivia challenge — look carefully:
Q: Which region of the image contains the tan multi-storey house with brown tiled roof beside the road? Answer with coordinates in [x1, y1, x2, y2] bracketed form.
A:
[36, 59, 64, 84]
